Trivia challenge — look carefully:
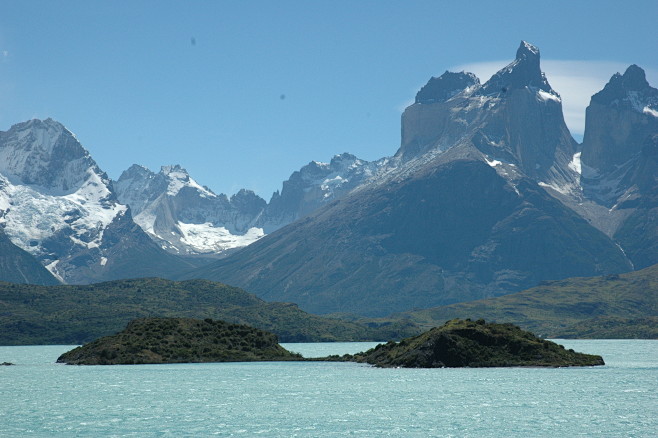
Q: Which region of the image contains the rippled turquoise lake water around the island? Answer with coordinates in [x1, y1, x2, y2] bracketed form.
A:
[0, 340, 658, 438]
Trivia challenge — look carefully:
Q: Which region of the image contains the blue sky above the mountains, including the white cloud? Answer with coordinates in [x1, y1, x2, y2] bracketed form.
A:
[0, 0, 658, 200]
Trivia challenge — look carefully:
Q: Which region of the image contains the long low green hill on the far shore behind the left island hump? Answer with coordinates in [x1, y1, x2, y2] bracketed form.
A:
[0, 278, 419, 345]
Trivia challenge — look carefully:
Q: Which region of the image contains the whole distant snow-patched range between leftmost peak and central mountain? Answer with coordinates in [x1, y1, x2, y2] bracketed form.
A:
[114, 153, 388, 258]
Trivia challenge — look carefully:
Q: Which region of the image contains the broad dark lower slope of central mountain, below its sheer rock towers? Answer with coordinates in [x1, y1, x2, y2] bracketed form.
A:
[191, 160, 627, 316]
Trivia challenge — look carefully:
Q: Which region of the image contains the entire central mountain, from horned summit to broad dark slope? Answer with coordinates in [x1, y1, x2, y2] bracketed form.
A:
[183, 42, 631, 316]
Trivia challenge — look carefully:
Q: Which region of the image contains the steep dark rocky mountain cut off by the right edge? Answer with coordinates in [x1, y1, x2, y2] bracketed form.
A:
[581, 65, 658, 269]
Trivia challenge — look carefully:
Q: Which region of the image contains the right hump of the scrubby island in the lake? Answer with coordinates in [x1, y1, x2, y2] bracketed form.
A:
[340, 319, 605, 368]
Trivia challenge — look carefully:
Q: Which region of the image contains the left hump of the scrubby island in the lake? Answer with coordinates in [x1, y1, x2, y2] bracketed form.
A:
[57, 318, 301, 365]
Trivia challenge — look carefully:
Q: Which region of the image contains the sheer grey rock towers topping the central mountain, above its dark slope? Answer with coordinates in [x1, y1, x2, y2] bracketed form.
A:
[396, 42, 579, 190]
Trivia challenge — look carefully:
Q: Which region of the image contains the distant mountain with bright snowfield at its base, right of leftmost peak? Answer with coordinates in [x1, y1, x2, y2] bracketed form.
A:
[114, 165, 266, 257]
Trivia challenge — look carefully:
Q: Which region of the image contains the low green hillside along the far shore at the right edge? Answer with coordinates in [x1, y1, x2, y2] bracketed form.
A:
[394, 265, 658, 339]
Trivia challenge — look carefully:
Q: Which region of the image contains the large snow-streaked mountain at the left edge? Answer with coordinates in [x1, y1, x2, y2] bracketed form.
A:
[0, 119, 195, 283]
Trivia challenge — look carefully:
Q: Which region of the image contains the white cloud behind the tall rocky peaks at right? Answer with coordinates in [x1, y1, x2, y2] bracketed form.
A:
[449, 59, 658, 136]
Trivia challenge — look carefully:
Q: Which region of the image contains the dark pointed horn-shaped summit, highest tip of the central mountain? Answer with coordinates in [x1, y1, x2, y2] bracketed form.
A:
[478, 41, 558, 96]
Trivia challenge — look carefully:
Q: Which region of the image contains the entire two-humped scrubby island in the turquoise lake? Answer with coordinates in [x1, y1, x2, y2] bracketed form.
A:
[57, 318, 604, 368]
